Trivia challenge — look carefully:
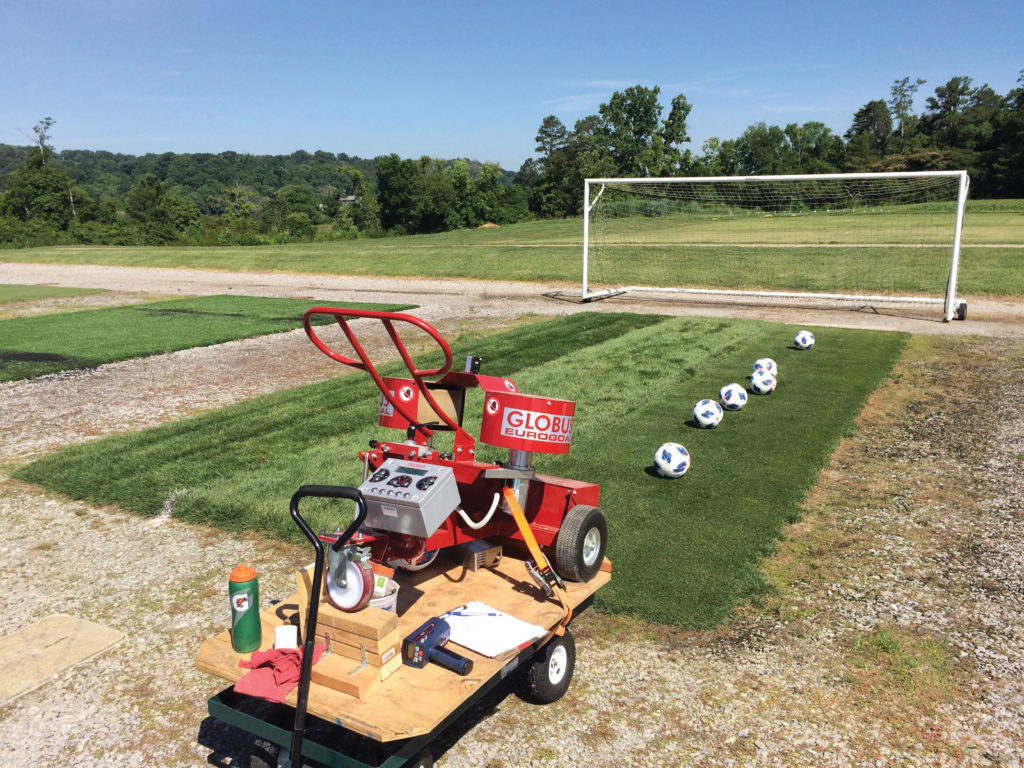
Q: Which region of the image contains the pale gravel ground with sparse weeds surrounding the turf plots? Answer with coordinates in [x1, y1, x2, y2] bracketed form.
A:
[0, 265, 1024, 768]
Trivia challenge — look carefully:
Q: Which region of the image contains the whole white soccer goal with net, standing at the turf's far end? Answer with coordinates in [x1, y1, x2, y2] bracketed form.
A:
[583, 171, 969, 321]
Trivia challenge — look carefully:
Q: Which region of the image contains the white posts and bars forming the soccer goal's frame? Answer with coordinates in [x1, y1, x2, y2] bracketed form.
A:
[582, 171, 970, 322]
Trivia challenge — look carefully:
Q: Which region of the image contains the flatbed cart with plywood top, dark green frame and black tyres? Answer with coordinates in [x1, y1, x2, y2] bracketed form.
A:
[197, 540, 611, 768]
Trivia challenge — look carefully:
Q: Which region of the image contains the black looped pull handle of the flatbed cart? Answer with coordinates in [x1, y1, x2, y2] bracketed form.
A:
[290, 485, 367, 766]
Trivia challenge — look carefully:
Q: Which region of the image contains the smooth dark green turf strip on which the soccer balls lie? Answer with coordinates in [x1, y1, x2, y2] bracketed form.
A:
[559, 325, 906, 629]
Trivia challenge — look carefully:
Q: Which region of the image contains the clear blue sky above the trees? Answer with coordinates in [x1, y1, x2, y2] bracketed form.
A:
[0, 0, 1024, 170]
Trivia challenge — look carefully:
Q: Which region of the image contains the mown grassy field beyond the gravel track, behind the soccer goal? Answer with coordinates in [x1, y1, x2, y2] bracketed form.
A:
[0, 201, 1024, 296]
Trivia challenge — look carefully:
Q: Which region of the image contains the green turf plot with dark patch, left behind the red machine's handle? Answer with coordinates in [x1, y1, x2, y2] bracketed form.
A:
[0, 296, 409, 381]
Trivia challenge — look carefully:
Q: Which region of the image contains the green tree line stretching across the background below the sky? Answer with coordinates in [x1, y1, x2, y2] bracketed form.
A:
[0, 70, 1024, 247]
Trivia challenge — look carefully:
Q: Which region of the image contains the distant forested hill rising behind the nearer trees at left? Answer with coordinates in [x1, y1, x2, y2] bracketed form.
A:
[0, 144, 514, 214]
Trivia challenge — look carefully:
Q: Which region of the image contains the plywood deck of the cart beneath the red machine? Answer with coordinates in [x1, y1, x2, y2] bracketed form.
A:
[196, 555, 611, 741]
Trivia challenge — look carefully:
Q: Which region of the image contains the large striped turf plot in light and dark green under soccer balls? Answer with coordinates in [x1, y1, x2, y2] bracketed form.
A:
[15, 313, 906, 628]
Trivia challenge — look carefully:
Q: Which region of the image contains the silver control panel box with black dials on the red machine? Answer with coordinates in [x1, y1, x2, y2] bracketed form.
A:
[359, 459, 461, 539]
